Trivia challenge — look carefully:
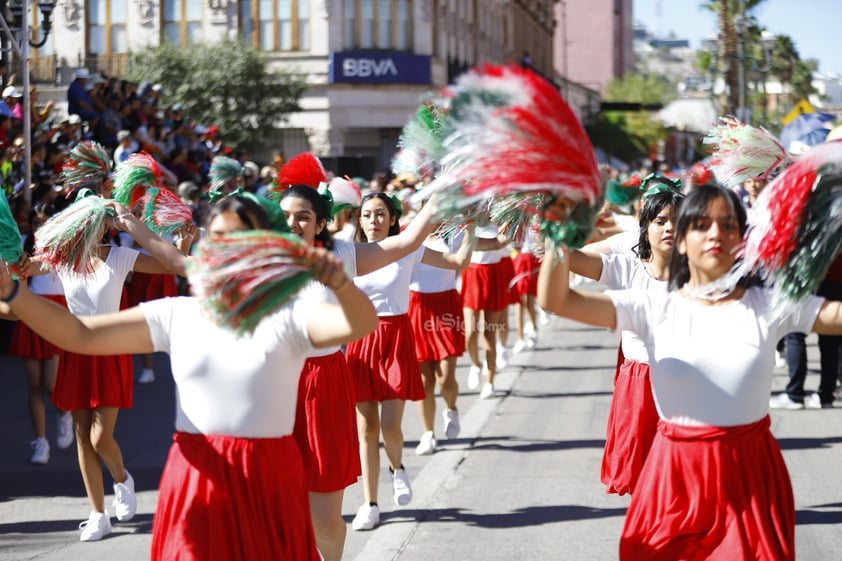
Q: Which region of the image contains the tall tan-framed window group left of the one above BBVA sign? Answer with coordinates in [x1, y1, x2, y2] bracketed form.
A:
[239, 0, 310, 51]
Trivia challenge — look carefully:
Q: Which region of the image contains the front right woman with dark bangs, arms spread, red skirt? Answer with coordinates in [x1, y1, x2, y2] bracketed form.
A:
[538, 186, 842, 561]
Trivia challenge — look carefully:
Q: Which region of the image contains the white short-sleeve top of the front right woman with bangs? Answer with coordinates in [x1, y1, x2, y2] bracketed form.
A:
[608, 288, 824, 427]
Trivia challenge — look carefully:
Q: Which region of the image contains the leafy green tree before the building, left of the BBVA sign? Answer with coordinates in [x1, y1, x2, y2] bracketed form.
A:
[128, 41, 307, 145]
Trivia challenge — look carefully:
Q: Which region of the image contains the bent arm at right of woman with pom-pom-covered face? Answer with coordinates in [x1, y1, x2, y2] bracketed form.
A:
[307, 249, 378, 348]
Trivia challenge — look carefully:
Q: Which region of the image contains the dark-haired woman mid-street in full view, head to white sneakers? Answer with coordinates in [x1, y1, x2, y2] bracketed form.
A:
[346, 193, 470, 530]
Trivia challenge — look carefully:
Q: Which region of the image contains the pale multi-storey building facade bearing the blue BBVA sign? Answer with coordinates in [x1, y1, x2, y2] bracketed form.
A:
[32, 0, 555, 176]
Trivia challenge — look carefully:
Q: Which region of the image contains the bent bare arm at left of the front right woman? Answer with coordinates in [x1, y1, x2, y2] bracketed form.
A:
[538, 248, 617, 329]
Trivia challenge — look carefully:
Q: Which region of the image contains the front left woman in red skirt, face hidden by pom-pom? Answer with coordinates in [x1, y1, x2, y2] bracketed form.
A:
[0, 196, 377, 561]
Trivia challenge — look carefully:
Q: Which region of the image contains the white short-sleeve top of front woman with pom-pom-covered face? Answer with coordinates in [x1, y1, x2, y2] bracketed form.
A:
[140, 296, 313, 438]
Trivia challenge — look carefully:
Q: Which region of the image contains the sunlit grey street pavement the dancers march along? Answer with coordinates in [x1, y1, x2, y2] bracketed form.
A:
[0, 312, 842, 561]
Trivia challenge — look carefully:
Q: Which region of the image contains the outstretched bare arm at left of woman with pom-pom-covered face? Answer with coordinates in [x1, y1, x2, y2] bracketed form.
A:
[0, 266, 154, 355]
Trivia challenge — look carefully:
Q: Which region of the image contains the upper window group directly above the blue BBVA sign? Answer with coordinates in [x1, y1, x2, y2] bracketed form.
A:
[343, 0, 412, 51]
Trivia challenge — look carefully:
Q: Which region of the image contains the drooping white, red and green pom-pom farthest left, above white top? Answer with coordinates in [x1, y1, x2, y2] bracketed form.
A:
[35, 197, 113, 275]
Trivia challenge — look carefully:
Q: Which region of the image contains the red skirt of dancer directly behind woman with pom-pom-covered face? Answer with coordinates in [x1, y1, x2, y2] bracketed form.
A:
[292, 351, 362, 493]
